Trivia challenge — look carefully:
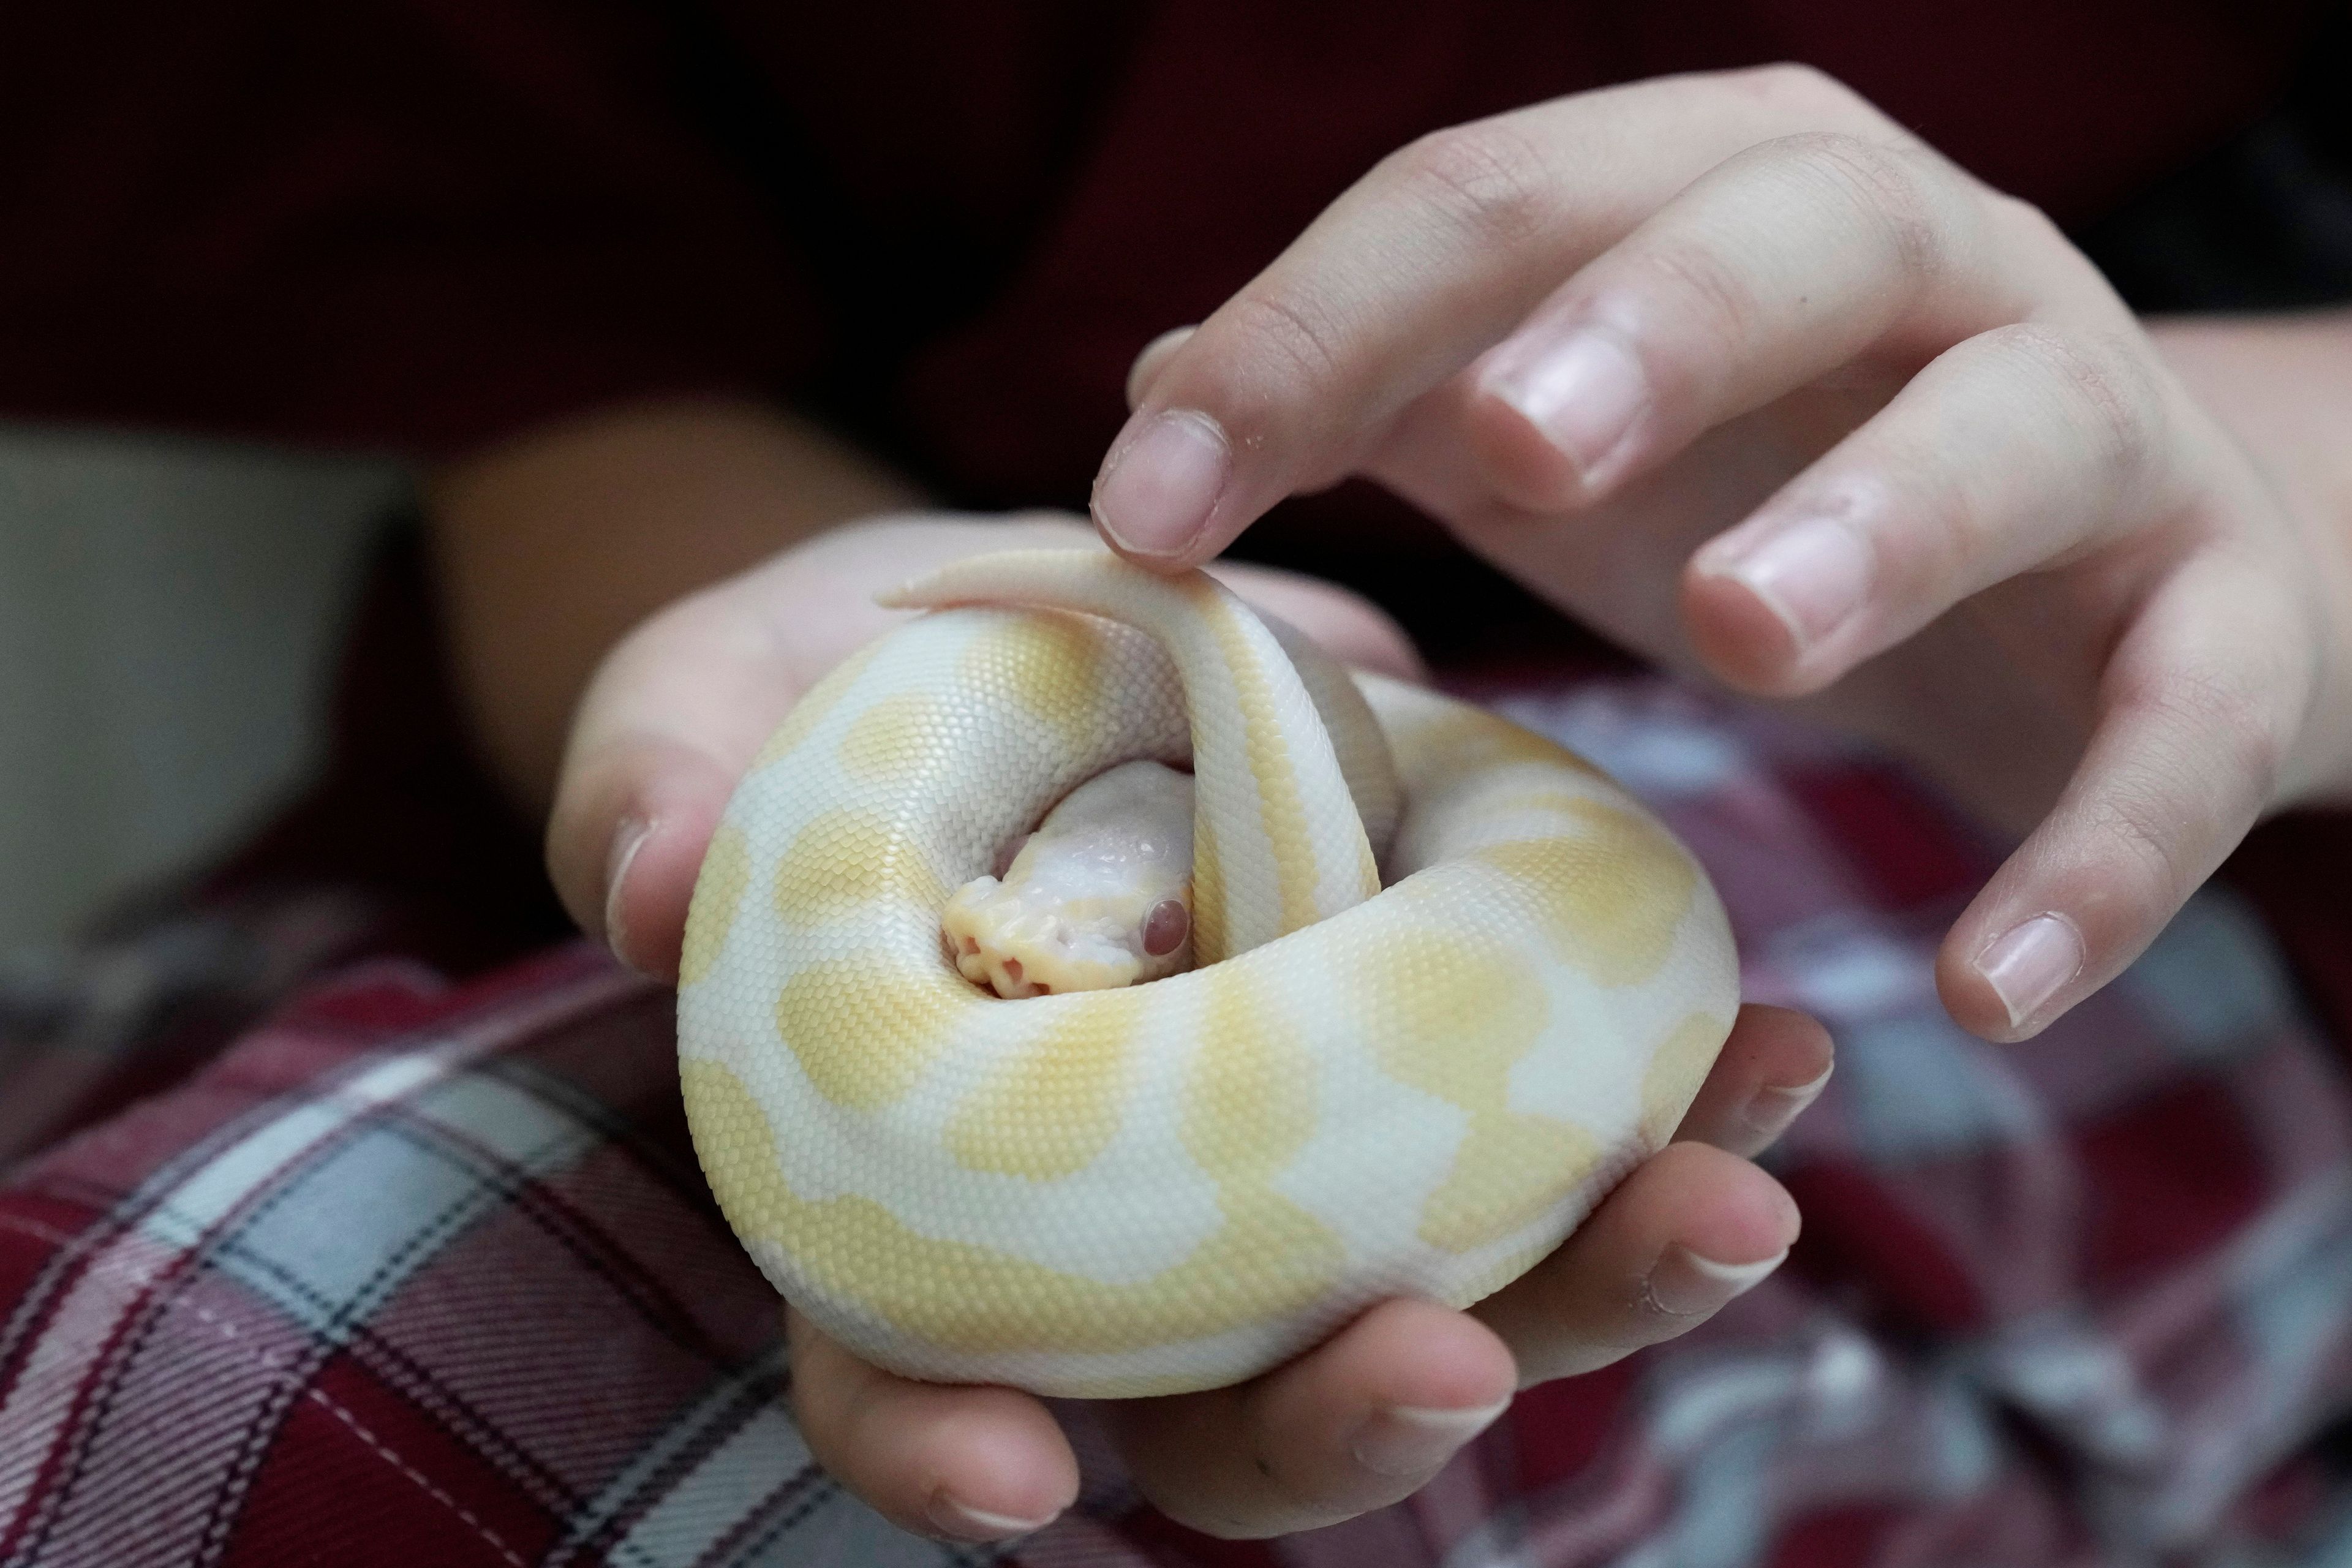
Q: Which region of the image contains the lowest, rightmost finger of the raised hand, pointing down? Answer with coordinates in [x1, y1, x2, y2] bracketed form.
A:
[1936, 548, 2324, 1039]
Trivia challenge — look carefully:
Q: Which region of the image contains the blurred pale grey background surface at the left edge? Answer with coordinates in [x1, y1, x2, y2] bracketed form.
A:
[0, 426, 407, 948]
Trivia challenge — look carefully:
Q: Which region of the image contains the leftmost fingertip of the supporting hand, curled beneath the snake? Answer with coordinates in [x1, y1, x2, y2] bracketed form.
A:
[786, 1312, 1077, 1540]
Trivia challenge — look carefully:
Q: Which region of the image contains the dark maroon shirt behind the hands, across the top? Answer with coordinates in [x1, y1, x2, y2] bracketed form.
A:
[0, 0, 2316, 475]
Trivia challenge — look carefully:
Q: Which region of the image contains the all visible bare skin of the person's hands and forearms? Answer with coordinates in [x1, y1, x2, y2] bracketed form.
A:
[431, 68, 2352, 1540]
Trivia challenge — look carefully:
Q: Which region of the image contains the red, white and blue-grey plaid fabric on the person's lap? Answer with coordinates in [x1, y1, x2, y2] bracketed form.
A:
[0, 679, 2352, 1568]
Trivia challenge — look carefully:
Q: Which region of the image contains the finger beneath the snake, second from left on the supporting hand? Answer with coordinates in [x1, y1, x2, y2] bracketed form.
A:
[1110, 1300, 1512, 1537]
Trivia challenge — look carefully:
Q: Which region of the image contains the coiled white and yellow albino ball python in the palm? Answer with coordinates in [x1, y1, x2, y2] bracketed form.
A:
[677, 550, 1738, 1396]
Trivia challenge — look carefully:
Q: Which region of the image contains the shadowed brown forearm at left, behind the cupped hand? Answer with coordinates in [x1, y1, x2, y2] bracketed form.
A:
[426, 399, 918, 813]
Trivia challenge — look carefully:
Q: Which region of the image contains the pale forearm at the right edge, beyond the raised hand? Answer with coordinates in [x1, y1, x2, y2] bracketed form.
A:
[2150, 311, 2352, 804]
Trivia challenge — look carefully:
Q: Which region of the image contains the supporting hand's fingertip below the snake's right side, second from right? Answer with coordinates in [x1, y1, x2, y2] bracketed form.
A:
[1470, 1142, 1797, 1387]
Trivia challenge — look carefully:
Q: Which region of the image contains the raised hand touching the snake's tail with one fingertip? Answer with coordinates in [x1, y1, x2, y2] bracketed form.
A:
[1094, 66, 2352, 1039]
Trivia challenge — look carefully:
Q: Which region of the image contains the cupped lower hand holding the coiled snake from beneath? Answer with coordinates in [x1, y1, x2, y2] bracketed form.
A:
[548, 517, 1830, 1540]
